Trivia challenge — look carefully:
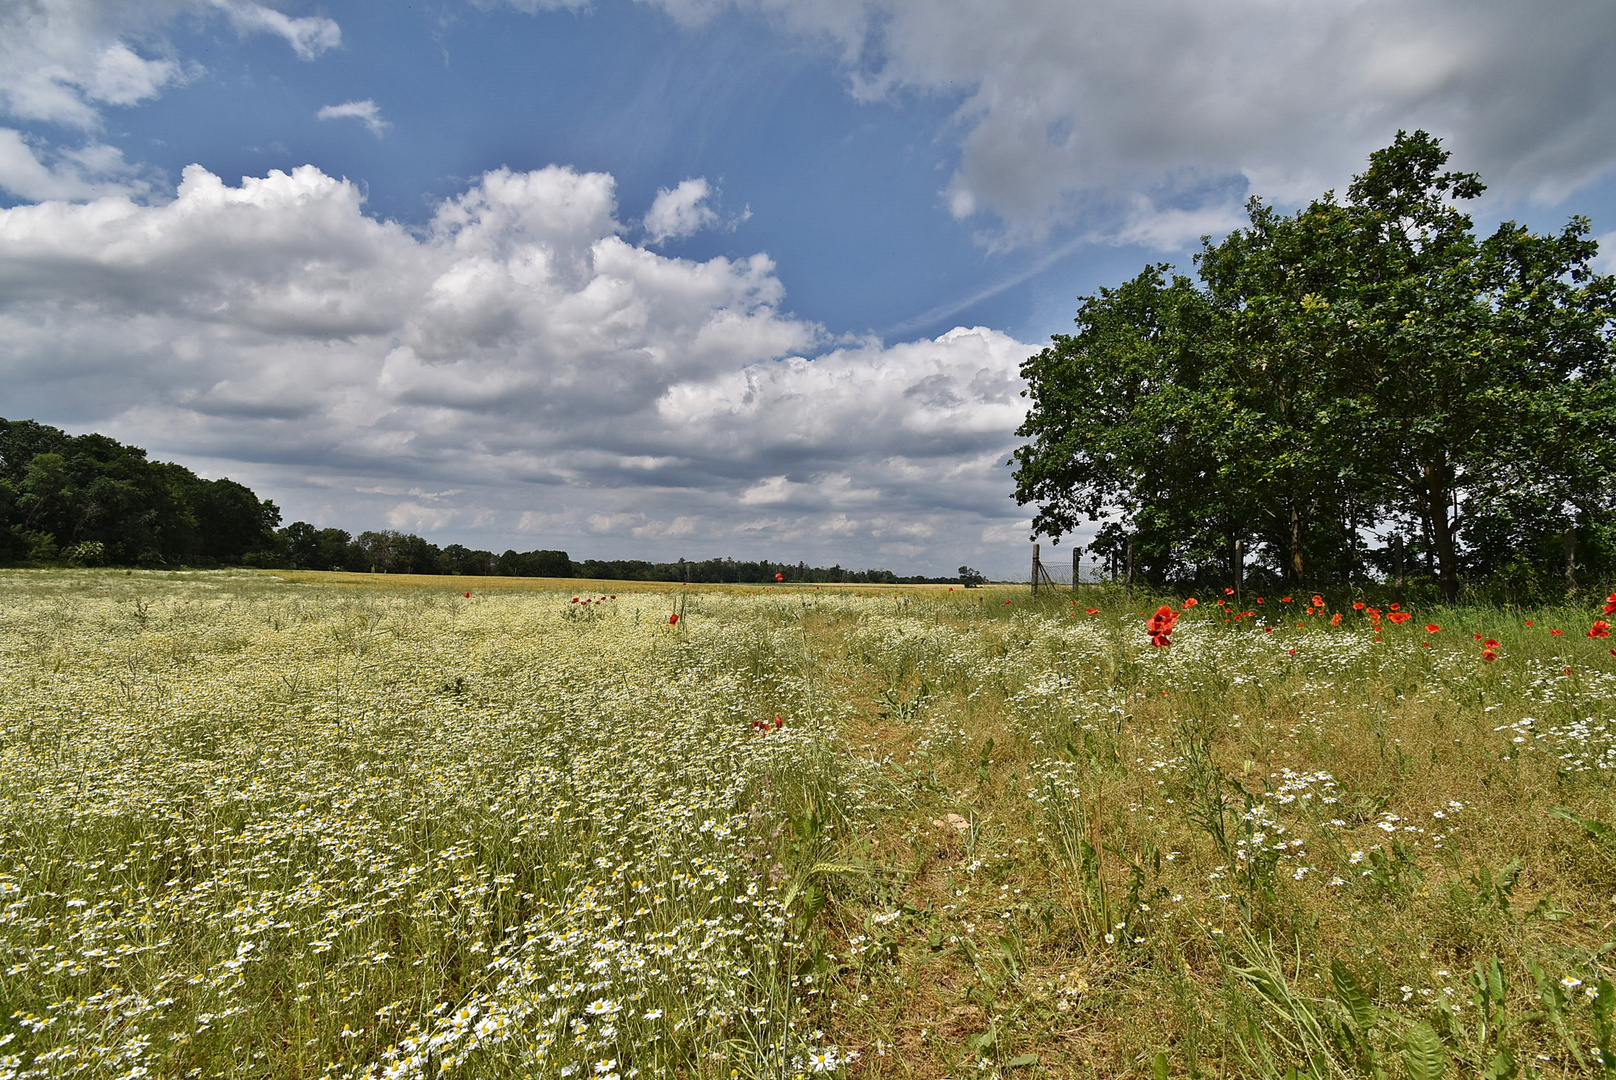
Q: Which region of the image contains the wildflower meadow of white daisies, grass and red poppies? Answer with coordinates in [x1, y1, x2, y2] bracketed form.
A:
[0, 571, 1616, 1080]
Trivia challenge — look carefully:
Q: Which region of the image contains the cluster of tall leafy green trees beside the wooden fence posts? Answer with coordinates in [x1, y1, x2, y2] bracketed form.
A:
[1012, 131, 1616, 601]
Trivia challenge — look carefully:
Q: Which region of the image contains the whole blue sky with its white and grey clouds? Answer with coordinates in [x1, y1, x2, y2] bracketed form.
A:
[0, 0, 1616, 577]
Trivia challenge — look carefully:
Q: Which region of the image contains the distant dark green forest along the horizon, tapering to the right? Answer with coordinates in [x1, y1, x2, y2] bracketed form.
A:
[0, 417, 957, 584]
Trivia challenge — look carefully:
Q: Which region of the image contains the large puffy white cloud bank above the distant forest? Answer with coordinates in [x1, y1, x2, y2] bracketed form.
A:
[0, 165, 1031, 569]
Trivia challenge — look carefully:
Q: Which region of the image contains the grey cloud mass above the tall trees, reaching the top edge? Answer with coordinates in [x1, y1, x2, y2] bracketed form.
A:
[620, 0, 1616, 244]
